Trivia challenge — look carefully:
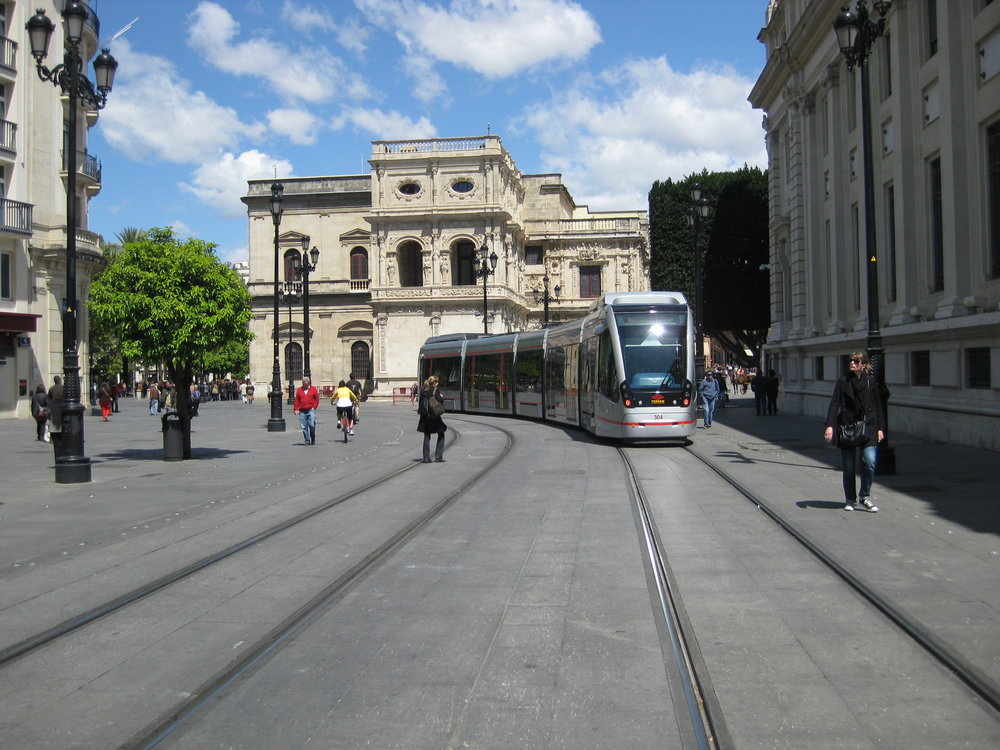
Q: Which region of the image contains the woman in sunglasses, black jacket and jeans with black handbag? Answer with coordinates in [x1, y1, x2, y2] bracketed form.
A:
[823, 352, 885, 513]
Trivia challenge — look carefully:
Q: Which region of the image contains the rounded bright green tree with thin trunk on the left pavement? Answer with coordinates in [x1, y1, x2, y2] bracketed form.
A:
[89, 228, 252, 458]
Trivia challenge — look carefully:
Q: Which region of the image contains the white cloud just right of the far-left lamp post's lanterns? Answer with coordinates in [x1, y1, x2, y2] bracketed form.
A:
[101, 39, 264, 163]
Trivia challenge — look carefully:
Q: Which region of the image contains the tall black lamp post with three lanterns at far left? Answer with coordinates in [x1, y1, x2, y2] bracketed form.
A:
[25, 0, 118, 484]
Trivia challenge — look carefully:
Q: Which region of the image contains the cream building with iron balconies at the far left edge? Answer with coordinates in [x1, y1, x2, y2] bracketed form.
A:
[0, 0, 104, 418]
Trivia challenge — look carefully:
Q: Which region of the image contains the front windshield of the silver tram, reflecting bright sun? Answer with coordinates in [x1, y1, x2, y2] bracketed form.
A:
[615, 310, 687, 391]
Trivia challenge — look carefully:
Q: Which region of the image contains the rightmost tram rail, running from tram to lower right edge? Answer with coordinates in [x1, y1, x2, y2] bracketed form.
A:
[685, 446, 1000, 712]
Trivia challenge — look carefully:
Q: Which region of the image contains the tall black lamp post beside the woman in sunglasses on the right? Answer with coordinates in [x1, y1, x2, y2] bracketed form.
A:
[833, 0, 896, 474]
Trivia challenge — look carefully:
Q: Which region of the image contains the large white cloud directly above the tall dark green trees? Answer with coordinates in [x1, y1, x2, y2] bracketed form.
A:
[515, 57, 767, 210]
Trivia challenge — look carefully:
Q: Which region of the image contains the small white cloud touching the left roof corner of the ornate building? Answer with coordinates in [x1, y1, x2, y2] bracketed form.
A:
[180, 149, 292, 219]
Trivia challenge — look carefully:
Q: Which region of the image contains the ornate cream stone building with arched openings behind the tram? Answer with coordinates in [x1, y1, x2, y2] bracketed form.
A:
[243, 135, 649, 397]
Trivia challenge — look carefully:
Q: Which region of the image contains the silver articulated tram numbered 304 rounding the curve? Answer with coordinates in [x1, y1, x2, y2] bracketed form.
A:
[418, 292, 696, 441]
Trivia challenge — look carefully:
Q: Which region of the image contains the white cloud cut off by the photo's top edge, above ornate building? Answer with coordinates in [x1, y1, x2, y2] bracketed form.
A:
[354, 0, 601, 78]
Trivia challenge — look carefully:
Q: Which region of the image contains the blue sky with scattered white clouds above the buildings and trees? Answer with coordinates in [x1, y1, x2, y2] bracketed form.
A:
[88, 0, 768, 262]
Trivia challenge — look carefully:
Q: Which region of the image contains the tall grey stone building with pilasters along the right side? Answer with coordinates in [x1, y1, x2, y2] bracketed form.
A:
[750, 0, 1000, 450]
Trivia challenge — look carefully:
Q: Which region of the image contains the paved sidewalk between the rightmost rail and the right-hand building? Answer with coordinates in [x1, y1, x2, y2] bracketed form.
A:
[692, 396, 1000, 704]
